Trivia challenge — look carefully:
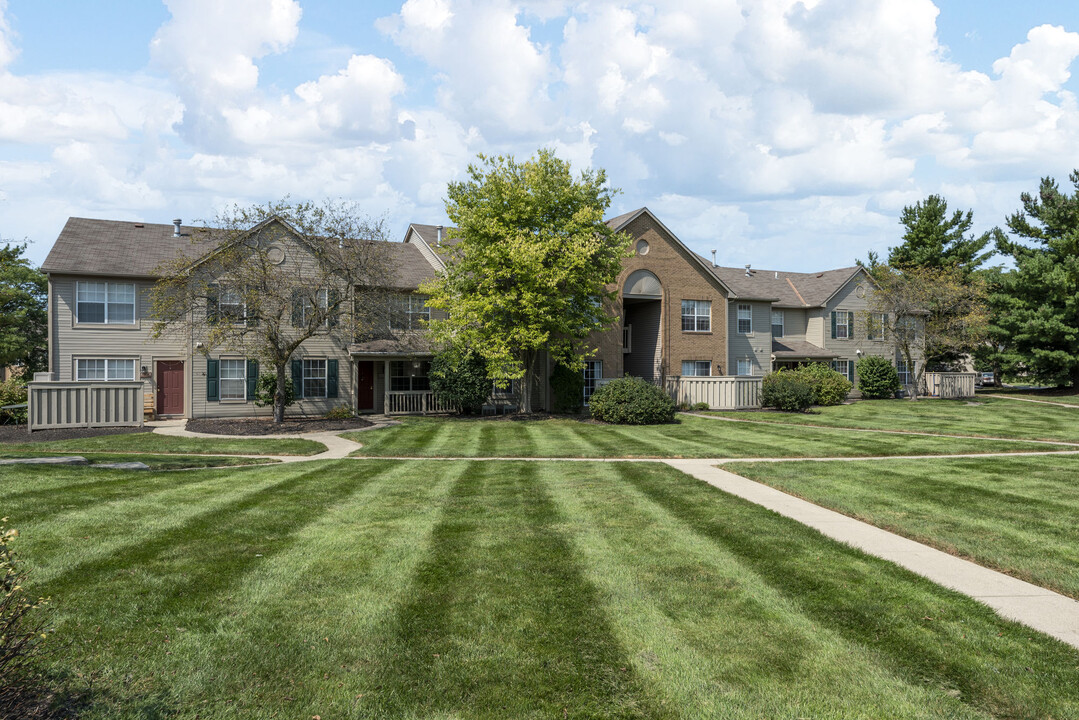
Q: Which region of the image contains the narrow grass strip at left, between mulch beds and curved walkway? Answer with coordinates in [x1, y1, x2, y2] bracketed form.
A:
[0, 433, 326, 456]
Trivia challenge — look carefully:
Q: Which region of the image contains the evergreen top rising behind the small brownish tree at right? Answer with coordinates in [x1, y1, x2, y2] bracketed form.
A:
[888, 195, 995, 276]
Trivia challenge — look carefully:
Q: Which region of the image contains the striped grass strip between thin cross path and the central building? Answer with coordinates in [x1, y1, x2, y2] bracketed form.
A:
[344, 416, 1067, 458]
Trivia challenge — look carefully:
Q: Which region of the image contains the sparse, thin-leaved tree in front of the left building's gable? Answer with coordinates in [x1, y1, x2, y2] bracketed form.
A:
[150, 199, 390, 422]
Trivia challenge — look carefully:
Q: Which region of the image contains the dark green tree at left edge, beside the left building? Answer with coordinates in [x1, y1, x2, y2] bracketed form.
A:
[0, 244, 49, 373]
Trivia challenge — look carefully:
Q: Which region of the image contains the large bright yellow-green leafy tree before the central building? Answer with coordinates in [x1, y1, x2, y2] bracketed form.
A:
[424, 150, 629, 412]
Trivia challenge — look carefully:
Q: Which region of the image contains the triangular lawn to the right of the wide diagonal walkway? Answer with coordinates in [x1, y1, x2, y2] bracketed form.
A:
[727, 457, 1079, 598]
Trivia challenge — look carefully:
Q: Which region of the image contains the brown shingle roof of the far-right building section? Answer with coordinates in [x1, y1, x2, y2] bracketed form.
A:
[711, 267, 864, 308]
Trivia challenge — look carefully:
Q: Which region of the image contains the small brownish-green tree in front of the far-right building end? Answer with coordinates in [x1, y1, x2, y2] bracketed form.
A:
[866, 266, 988, 399]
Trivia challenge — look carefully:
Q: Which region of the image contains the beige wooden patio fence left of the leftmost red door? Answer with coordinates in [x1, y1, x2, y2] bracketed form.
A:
[27, 382, 142, 431]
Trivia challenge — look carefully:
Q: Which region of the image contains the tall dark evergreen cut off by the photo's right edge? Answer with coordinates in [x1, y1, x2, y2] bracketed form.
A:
[991, 171, 1079, 388]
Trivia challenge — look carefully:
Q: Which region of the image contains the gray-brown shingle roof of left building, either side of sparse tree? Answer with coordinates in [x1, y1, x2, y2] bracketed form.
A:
[41, 218, 435, 289]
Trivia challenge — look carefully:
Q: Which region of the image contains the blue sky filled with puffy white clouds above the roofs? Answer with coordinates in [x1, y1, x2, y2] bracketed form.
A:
[0, 0, 1079, 271]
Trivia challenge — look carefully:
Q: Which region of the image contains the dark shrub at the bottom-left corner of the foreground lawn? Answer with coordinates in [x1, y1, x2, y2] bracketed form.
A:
[0, 517, 46, 717]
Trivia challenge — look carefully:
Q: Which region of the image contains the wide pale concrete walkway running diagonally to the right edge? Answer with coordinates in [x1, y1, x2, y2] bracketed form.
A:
[667, 460, 1079, 648]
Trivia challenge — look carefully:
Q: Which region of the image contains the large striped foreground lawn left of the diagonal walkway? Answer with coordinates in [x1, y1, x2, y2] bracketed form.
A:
[8, 461, 1079, 720]
